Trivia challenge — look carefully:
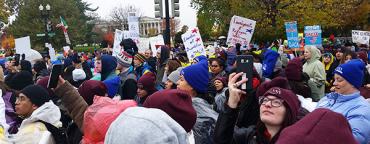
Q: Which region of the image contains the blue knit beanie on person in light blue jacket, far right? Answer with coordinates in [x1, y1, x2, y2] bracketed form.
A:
[334, 59, 365, 89]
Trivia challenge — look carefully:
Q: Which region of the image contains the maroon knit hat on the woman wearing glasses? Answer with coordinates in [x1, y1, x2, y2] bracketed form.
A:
[263, 87, 300, 121]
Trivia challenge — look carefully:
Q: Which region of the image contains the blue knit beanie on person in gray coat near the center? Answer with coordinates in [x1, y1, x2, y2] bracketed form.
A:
[182, 59, 209, 93]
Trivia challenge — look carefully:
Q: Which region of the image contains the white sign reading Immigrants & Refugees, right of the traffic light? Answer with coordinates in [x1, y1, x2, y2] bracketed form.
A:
[226, 16, 256, 47]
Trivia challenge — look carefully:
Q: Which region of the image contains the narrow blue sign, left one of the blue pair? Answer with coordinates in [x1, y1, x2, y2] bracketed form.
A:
[285, 21, 299, 48]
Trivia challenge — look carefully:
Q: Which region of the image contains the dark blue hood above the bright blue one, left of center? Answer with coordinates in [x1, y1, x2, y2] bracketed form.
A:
[101, 55, 117, 81]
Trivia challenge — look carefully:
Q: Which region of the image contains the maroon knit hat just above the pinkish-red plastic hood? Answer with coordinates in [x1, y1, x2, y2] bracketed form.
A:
[78, 80, 108, 105]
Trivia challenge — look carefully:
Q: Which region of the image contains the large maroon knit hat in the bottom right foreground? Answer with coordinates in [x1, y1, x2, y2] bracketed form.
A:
[276, 108, 357, 144]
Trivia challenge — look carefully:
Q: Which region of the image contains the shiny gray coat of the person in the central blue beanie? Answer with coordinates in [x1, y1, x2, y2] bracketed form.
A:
[192, 97, 218, 144]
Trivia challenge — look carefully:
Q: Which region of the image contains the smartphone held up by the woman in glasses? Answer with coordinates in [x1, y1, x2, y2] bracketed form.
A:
[236, 55, 253, 90]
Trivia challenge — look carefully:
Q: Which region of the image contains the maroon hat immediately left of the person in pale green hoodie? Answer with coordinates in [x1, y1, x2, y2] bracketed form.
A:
[285, 58, 303, 81]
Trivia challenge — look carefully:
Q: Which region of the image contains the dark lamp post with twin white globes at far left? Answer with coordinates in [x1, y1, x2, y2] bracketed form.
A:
[39, 4, 52, 54]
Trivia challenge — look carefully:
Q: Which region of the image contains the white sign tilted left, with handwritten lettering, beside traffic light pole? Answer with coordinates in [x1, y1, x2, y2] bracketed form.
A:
[181, 27, 206, 60]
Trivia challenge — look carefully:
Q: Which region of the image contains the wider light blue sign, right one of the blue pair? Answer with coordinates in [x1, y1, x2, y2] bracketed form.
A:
[304, 25, 322, 48]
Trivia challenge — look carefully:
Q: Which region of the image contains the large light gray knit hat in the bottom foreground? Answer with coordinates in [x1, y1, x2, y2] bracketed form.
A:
[104, 107, 188, 144]
